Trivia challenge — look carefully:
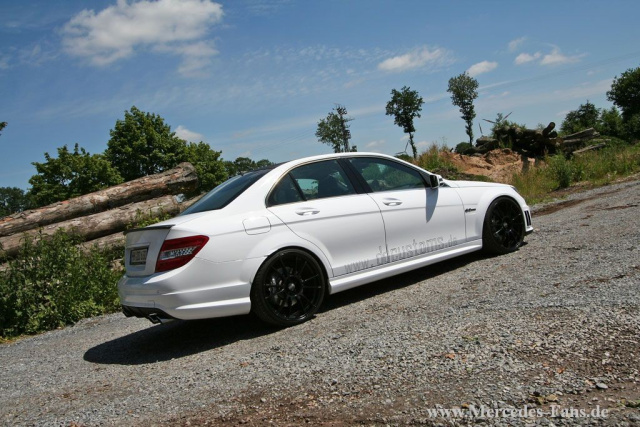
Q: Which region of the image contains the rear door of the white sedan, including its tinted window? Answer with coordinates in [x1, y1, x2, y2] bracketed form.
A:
[267, 160, 385, 276]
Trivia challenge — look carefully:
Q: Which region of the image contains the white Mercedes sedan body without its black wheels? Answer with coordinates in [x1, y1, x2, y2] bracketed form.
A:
[118, 153, 533, 322]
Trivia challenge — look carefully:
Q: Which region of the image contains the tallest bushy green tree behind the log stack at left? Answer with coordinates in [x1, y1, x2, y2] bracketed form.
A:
[105, 106, 187, 181]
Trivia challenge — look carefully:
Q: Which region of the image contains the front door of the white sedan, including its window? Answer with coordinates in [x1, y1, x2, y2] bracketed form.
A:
[348, 157, 466, 262]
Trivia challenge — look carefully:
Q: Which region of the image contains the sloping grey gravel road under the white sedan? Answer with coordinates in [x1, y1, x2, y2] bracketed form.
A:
[0, 180, 640, 426]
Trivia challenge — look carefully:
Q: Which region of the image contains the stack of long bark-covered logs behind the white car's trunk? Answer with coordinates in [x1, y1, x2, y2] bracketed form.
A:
[0, 163, 198, 257]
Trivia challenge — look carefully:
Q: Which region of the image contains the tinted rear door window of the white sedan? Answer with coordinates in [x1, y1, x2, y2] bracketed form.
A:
[268, 160, 356, 206]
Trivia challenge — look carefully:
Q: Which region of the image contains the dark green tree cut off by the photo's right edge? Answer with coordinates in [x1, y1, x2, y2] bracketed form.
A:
[607, 67, 640, 138]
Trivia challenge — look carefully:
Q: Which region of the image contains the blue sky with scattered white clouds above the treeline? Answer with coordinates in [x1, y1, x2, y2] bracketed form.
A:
[0, 0, 640, 189]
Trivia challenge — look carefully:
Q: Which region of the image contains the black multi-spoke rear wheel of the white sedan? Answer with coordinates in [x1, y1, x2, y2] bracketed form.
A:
[251, 249, 326, 326]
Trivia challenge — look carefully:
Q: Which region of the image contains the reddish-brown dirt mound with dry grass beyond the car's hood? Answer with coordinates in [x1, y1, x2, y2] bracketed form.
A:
[441, 148, 534, 182]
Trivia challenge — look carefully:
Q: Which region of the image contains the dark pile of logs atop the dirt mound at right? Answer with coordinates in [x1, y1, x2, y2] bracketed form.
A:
[473, 122, 604, 157]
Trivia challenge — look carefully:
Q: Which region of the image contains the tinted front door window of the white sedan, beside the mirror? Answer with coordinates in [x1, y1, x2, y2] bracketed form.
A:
[349, 157, 425, 193]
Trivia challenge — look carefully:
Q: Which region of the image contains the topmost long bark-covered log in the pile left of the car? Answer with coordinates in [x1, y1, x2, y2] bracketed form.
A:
[0, 163, 198, 237]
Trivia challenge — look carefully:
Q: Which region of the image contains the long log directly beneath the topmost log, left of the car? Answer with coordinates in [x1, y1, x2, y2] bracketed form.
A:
[0, 195, 189, 257]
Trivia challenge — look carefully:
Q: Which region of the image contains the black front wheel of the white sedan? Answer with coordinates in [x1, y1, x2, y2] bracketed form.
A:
[482, 197, 525, 255]
